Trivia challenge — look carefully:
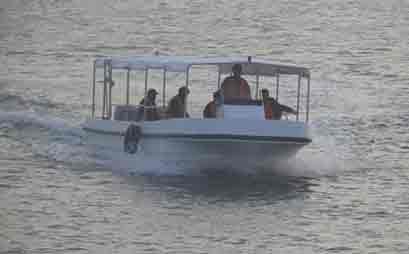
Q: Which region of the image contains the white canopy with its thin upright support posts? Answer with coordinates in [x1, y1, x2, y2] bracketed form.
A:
[91, 56, 311, 122]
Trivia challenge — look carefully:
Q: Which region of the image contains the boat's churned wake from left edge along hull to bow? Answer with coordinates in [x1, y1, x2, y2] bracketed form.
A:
[0, 111, 340, 177]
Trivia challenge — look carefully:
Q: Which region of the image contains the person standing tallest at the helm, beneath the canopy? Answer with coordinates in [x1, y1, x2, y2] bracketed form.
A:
[222, 64, 251, 100]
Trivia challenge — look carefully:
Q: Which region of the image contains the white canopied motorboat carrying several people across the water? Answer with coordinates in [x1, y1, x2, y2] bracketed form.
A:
[83, 56, 312, 169]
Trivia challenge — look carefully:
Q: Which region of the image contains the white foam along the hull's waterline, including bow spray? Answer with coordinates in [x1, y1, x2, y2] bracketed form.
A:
[0, 111, 345, 177]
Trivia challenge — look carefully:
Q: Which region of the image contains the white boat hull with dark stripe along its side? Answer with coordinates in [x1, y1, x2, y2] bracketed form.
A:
[84, 119, 311, 169]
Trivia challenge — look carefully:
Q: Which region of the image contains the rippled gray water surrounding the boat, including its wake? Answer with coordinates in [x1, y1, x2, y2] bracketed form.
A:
[0, 0, 409, 253]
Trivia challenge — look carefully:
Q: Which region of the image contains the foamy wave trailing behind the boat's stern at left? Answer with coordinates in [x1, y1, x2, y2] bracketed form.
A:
[0, 111, 95, 163]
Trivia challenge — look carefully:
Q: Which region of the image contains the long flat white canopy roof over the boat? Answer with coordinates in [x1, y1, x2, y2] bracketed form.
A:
[95, 56, 310, 78]
